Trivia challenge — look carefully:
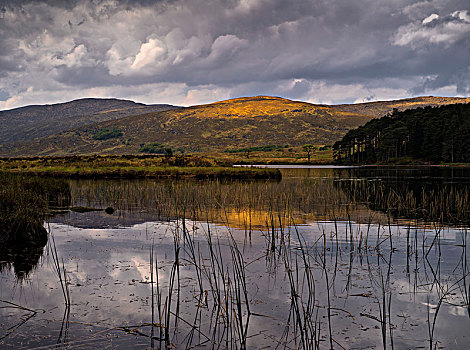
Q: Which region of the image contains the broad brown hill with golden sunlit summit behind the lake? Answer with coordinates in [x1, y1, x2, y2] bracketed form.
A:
[0, 96, 470, 156]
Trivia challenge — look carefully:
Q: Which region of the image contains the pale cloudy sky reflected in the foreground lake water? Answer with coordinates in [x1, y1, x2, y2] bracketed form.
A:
[0, 221, 469, 349]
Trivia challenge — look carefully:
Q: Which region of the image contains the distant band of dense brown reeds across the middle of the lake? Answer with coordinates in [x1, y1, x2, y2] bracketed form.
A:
[66, 173, 470, 230]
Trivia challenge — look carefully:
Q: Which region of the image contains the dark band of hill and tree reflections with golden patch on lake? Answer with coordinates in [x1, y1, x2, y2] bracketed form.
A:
[50, 167, 470, 230]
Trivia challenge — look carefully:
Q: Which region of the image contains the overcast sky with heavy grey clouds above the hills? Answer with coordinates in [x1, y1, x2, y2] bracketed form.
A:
[0, 0, 470, 110]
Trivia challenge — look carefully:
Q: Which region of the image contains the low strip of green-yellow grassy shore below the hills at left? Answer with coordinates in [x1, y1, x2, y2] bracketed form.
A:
[0, 156, 281, 179]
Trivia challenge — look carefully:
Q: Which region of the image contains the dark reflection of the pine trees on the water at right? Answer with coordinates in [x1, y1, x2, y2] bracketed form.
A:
[335, 167, 470, 225]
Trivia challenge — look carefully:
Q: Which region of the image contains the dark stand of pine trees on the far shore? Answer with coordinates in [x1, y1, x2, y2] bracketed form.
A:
[333, 104, 470, 164]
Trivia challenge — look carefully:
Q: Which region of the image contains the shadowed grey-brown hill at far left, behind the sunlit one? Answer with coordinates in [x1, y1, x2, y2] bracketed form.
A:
[0, 98, 177, 144]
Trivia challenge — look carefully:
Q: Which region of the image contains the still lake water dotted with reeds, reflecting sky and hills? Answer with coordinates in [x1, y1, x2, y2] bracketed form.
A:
[0, 167, 470, 349]
